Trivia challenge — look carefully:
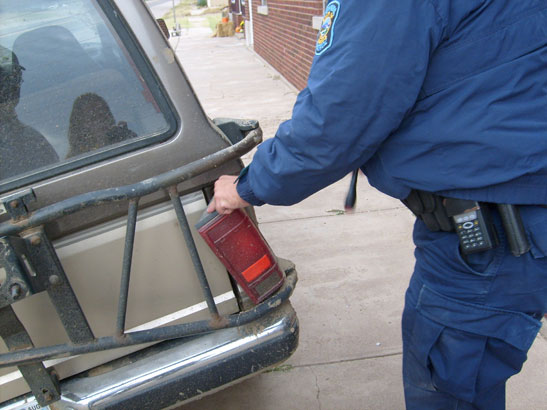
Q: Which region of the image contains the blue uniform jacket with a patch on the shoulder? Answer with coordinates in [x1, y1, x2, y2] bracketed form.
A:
[237, 0, 547, 205]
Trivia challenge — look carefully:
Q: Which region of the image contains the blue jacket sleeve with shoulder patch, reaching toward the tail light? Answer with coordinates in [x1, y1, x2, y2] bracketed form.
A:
[237, 0, 445, 205]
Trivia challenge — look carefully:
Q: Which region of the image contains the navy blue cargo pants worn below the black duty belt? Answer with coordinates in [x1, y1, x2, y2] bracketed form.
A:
[402, 206, 547, 410]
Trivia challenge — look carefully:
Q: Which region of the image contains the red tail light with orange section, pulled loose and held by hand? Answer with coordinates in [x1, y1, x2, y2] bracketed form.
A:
[196, 209, 284, 303]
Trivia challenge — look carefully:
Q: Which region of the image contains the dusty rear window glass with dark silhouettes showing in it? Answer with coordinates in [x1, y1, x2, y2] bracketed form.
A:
[0, 0, 172, 186]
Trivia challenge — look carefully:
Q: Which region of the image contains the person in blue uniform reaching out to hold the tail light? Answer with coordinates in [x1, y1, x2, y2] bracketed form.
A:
[209, 0, 547, 410]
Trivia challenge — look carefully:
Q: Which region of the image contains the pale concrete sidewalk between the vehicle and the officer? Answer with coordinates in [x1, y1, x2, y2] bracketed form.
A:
[171, 29, 547, 410]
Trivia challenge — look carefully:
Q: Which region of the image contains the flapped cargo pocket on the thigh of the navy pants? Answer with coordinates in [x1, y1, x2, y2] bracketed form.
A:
[407, 286, 540, 408]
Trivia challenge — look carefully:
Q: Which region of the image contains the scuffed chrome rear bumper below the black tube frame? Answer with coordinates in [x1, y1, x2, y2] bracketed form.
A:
[1, 301, 299, 410]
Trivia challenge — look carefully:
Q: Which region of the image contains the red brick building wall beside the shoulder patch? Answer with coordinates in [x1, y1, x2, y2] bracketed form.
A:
[253, 0, 323, 90]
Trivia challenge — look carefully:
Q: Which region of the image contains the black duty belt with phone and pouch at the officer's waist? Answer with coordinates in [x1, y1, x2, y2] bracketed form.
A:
[402, 190, 530, 257]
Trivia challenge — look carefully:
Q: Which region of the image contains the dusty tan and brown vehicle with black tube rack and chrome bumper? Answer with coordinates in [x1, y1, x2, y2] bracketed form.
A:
[0, 0, 298, 409]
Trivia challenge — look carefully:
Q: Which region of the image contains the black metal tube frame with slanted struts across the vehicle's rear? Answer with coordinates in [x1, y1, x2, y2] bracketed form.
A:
[0, 128, 296, 367]
